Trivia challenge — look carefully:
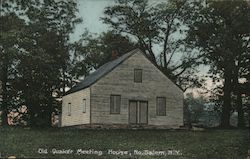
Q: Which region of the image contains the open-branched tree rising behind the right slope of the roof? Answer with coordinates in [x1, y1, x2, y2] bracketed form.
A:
[102, 0, 201, 89]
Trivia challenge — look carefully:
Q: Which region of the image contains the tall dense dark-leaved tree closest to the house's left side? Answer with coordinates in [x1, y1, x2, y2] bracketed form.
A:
[19, 1, 81, 125]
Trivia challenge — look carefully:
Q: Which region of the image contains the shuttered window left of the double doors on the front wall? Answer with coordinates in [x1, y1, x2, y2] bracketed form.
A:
[110, 95, 121, 114]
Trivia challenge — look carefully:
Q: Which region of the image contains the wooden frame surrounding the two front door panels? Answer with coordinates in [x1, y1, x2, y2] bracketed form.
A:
[128, 99, 148, 125]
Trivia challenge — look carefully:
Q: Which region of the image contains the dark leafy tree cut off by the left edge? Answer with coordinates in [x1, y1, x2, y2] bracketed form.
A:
[0, 2, 25, 125]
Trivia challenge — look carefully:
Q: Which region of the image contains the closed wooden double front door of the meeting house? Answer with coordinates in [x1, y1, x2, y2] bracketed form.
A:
[129, 100, 148, 124]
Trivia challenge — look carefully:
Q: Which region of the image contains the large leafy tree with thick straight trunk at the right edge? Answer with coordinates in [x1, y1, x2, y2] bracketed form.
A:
[188, 1, 250, 127]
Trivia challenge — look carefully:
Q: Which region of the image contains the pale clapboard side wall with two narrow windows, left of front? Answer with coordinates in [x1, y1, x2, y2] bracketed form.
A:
[61, 88, 90, 126]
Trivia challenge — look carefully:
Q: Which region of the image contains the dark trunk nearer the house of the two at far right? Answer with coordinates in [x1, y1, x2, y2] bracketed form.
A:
[221, 67, 232, 128]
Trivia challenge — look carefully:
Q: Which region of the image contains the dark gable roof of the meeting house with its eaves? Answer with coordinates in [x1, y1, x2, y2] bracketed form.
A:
[64, 49, 183, 95]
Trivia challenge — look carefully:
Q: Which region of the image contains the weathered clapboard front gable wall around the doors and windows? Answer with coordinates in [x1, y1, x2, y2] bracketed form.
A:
[91, 51, 183, 127]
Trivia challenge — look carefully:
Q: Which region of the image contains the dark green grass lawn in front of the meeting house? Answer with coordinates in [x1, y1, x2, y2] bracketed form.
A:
[0, 127, 250, 159]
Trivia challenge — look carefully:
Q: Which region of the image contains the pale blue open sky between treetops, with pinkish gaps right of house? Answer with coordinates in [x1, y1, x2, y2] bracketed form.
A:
[71, 0, 213, 96]
